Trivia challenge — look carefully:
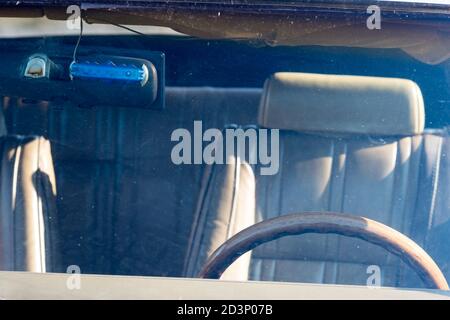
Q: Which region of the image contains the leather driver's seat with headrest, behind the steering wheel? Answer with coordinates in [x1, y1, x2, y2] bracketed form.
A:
[185, 73, 450, 287]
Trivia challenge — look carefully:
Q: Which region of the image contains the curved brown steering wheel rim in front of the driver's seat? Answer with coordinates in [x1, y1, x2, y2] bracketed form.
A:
[198, 212, 449, 290]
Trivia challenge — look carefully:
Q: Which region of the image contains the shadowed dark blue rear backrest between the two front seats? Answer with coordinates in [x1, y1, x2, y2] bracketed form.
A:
[0, 87, 262, 276]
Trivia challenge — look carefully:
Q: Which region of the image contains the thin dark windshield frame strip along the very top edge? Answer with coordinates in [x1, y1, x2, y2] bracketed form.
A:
[0, 0, 450, 18]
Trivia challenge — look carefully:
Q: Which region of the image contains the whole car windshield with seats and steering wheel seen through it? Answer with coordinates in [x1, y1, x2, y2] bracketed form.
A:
[0, 0, 450, 296]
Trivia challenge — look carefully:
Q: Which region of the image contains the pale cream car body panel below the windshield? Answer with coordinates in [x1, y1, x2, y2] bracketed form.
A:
[0, 271, 450, 300]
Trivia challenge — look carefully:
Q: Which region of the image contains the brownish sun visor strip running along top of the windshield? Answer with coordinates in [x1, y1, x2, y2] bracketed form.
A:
[75, 9, 450, 64]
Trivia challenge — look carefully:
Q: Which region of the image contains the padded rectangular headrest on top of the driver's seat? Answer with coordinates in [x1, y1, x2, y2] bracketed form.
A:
[259, 72, 425, 136]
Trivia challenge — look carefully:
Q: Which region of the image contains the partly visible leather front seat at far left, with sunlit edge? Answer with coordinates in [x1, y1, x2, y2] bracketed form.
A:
[0, 136, 56, 272]
